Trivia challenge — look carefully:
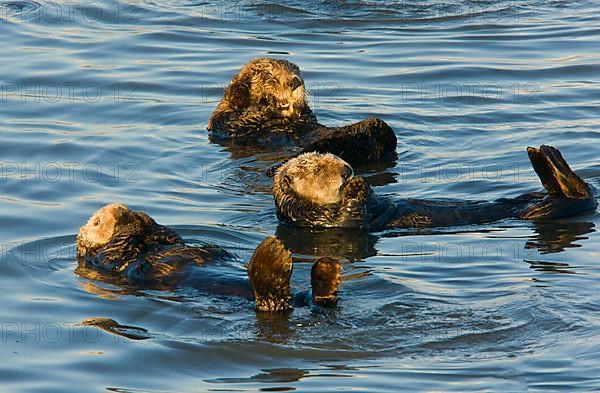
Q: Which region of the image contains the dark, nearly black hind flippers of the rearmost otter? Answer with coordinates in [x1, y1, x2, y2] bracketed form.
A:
[303, 118, 397, 164]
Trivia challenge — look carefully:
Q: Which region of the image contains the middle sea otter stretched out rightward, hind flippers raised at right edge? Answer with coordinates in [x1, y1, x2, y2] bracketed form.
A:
[273, 146, 596, 231]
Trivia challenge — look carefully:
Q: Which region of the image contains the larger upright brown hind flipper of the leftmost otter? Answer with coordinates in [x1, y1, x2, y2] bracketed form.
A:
[248, 237, 292, 311]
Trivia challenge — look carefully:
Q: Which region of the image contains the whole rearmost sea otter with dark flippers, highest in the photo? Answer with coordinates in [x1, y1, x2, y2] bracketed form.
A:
[207, 58, 396, 164]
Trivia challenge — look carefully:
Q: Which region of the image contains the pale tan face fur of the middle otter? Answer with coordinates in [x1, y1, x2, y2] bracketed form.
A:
[274, 153, 354, 205]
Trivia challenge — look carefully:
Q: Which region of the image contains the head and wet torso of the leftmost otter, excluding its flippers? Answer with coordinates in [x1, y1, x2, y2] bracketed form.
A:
[77, 204, 225, 287]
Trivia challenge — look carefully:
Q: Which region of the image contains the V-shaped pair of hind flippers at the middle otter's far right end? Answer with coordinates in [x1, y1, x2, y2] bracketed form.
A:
[521, 145, 596, 219]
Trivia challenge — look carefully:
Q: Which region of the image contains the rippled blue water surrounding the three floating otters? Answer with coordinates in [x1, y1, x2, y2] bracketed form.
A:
[0, 0, 600, 392]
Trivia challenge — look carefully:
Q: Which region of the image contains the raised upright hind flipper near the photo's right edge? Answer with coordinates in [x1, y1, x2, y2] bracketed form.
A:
[527, 145, 592, 199]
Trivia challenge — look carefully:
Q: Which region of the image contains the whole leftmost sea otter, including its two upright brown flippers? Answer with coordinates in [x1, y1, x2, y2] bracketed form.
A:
[77, 204, 341, 311]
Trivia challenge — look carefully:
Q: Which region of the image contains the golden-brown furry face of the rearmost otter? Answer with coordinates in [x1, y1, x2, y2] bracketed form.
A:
[232, 58, 306, 118]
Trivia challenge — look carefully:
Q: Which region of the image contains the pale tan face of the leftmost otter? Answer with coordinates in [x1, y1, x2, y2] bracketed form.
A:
[77, 203, 136, 254]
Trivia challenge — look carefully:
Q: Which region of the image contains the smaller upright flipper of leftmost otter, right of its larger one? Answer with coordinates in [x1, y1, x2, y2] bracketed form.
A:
[310, 257, 342, 306]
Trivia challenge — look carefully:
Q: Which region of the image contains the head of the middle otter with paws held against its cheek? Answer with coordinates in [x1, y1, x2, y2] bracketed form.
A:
[273, 153, 370, 227]
